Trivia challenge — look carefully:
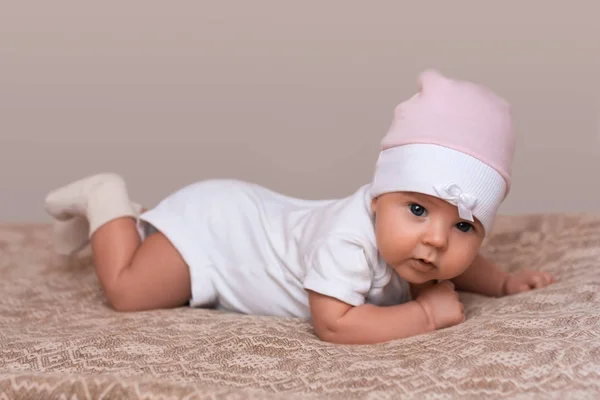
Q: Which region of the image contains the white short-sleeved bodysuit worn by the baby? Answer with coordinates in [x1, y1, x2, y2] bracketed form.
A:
[138, 179, 410, 318]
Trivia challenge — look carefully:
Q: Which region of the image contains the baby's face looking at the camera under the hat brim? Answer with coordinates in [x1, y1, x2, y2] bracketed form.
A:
[372, 192, 484, 284]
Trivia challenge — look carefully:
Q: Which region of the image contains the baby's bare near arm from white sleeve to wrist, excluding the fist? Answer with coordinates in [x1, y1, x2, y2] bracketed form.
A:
[308, 290, 435, 344]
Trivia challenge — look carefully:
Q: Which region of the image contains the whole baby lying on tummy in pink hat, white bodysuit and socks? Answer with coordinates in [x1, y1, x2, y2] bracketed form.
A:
[45, 70, 554, 344]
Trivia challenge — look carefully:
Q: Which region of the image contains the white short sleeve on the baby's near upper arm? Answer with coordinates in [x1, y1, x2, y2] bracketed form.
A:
[303, 237, 373, 306]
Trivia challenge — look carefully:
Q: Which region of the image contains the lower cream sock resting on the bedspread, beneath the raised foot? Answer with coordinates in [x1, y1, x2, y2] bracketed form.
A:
[52, 202, 142, 255]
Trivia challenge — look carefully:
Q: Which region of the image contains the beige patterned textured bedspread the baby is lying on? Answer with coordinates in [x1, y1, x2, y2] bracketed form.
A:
[0, 216, 600, 399]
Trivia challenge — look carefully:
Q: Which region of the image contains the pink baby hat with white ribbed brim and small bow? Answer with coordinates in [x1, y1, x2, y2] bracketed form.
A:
[371, 70, 516, 232]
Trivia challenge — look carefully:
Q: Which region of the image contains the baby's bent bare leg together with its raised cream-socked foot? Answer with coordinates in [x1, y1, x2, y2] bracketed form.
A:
[45, 174, 191, 311]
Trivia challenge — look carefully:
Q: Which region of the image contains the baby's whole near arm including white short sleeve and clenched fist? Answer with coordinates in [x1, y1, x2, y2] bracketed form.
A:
[303, 237, 464, 344]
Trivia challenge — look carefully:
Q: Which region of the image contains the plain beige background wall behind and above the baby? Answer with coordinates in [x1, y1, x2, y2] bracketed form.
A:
[0, 0, 600, 221]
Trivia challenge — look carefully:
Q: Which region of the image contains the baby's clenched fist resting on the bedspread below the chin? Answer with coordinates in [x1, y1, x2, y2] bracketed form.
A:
[416, 281, 465, 329]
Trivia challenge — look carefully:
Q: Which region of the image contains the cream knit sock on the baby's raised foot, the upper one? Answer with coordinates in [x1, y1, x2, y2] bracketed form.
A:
[44, 174, 136, 237]
